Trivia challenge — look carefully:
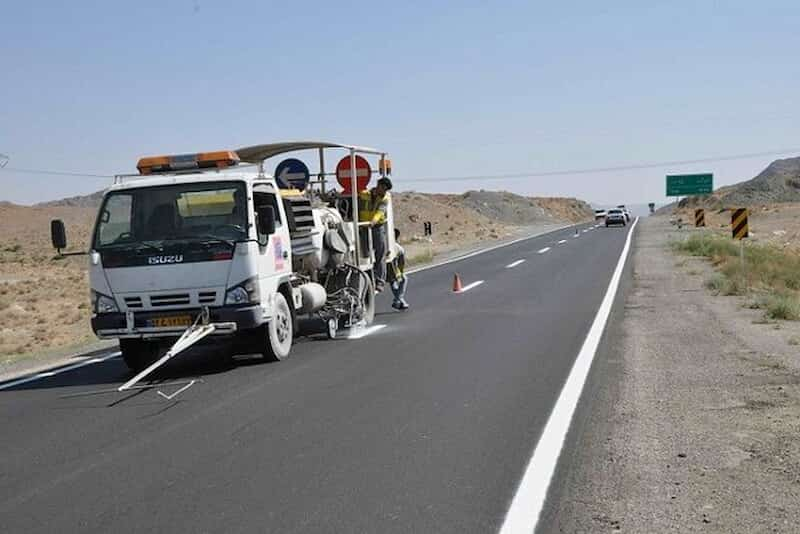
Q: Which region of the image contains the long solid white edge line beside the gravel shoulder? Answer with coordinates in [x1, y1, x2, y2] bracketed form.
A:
[500, 218, 639, 534]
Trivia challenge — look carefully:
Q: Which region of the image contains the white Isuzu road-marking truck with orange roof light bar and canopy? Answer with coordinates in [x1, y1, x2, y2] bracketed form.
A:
[51, 142, 394, 372]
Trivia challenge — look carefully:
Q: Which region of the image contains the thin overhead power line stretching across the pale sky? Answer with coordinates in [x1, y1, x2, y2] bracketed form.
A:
[0, 148, 800, 183]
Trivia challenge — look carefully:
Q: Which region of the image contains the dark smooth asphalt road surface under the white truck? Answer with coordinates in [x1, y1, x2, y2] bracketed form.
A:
[0, 221, 627, 533]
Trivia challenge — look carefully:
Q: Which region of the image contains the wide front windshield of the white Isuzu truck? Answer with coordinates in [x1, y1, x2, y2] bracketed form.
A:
[94, 182, 247, 250]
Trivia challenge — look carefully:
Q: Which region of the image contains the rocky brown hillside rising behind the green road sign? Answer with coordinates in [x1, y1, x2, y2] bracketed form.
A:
[662, 157, 800, 210]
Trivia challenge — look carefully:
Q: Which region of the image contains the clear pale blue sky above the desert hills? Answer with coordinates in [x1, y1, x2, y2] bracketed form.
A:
[0, 0, 800, 203]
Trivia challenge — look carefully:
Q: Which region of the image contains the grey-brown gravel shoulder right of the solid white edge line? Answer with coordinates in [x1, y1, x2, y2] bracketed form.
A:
[540, 217, 800, 533]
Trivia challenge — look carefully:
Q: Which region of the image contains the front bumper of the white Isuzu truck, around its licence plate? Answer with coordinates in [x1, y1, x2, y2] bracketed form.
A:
[92, 305, 266, 339]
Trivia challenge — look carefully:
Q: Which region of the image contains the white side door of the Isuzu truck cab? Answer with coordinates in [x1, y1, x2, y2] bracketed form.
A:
[253, 183, 292, 308]
